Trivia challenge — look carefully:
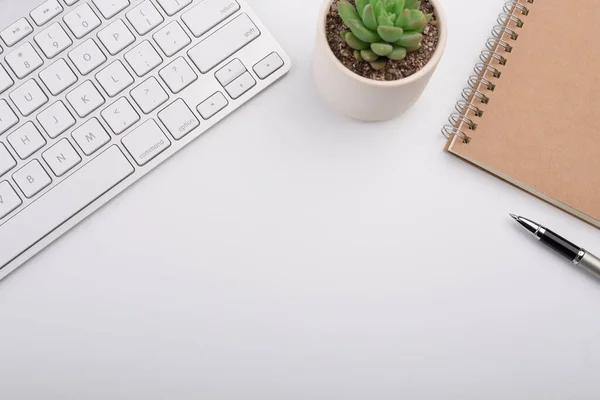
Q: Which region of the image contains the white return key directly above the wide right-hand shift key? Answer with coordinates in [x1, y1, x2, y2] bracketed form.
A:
[181, 0, 240, 37]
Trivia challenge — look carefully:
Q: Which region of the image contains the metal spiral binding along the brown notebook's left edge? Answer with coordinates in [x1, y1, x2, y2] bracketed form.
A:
[442, 0, 534, 143]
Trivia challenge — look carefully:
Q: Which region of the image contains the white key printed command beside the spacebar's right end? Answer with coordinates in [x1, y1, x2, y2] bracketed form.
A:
[121, 119, 171, 166]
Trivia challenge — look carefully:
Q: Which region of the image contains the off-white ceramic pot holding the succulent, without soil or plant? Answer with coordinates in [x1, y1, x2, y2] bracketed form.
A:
[313, 0, 447, 121]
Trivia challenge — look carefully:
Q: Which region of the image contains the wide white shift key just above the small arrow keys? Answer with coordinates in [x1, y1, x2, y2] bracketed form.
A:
[188, 13, 260, 74]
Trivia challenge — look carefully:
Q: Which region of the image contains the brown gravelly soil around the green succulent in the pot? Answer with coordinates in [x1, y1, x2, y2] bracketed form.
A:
[325, 0, 440, 81]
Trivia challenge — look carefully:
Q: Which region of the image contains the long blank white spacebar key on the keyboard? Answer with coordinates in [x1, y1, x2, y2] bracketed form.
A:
[0, 146, 134, 269]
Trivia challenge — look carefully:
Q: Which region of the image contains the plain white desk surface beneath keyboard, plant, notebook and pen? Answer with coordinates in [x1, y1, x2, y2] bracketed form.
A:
[0, 0, 600, 400]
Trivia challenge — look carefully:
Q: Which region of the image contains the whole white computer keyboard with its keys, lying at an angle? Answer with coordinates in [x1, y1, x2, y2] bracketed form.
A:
[0, 0, 290, 278]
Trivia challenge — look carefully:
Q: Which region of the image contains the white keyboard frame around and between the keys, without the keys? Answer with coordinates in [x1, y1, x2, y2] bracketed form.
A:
[0, 0, 291, 279]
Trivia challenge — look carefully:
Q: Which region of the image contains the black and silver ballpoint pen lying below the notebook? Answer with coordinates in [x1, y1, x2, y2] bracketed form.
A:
[510, 214, 600, 278]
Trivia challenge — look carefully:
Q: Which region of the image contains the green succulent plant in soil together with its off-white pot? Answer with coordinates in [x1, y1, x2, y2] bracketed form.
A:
[313, 0, 446, 121]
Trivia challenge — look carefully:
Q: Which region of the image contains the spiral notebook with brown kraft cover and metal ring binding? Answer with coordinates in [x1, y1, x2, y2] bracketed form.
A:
[443, 0, 600, 228]
